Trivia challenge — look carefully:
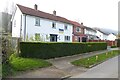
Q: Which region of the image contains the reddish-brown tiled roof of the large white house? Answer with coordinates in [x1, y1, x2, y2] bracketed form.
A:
[17, 4, 71, 24]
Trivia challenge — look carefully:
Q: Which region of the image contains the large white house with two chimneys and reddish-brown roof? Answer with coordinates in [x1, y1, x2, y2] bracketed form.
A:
[12, 4, 73, 42]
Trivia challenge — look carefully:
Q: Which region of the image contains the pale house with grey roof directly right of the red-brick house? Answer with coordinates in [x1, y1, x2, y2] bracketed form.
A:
[84, 26, 99, 40]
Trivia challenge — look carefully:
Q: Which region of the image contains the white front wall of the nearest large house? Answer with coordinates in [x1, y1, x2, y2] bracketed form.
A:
[22, 15, 73, 42]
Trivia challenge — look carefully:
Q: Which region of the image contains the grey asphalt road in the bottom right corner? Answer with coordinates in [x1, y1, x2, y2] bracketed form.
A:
[72, 56, 120, 78]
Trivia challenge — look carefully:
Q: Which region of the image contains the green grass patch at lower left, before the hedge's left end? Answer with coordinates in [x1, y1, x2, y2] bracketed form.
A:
[2, 55, 52, 77]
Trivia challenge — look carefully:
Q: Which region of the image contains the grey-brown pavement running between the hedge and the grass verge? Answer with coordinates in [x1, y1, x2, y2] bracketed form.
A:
[9, 48, 118, 78]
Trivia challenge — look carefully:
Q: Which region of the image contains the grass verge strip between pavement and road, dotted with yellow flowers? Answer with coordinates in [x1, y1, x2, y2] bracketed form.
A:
[71, 50, 120, 68]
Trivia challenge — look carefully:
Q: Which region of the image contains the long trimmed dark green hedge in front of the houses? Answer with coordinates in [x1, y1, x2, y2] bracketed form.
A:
[20, 42, 107, 59]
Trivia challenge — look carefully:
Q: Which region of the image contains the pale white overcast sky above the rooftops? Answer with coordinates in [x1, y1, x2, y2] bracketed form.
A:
[0, 0, 120, 31]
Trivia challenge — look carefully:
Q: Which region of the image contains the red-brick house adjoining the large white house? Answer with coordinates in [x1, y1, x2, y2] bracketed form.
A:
[71, 21, 87, 42]
